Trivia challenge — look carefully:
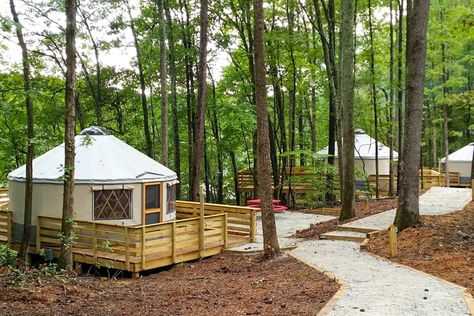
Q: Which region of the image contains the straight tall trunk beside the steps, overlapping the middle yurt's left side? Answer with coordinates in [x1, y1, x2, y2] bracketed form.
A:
[339, 0, 355, 220]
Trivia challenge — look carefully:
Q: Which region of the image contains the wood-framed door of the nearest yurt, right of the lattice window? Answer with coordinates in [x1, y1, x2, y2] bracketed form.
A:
[143, 182, 163, 225]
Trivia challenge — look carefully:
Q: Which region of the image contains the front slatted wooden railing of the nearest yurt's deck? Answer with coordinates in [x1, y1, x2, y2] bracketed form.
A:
[36, 213, 227, 273]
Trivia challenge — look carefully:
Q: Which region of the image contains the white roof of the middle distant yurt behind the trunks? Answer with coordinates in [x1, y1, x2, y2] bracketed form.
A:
[318, 129, 398, 159]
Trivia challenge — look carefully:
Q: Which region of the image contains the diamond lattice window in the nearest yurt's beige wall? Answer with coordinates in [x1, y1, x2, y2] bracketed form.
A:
[94, 189, 132, 219]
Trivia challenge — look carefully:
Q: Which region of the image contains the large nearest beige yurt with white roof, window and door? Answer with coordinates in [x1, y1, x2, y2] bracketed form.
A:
[8, 127, 178, 241]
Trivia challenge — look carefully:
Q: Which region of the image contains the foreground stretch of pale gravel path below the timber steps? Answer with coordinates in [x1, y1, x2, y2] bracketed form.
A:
[290, 240, 470, 316]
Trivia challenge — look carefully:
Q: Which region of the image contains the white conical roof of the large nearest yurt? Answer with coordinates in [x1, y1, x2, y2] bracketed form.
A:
[8, 128, 177, 184]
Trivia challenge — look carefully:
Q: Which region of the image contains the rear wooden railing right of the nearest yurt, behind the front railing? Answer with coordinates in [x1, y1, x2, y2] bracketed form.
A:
[176, 201, 259, 245]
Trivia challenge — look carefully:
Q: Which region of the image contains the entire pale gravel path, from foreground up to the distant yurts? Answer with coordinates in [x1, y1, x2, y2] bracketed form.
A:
[234, 188, 471, 316]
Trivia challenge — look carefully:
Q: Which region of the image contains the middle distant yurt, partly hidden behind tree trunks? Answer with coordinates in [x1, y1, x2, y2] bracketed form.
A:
[318, 129, 398, 176]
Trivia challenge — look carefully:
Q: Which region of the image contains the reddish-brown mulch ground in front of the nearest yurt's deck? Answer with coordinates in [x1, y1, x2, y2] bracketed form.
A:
[0, 253, 339, 315]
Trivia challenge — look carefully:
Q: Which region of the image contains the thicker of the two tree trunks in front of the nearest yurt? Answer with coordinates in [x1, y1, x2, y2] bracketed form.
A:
[59, 0, 77, 269]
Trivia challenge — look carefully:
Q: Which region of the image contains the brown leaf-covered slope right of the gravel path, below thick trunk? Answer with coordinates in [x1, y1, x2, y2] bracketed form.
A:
[367, 202, 474, 294]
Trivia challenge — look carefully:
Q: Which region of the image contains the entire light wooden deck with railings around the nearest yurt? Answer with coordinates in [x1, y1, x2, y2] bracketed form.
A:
[0, 190, 258, 274]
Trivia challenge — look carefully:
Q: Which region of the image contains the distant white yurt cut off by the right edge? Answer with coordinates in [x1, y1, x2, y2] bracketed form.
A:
[440, 143, 474, 184]
